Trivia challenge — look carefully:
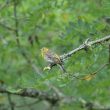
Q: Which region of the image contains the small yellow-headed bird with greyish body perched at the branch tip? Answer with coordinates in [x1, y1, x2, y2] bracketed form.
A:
[41, 47, 66, 72]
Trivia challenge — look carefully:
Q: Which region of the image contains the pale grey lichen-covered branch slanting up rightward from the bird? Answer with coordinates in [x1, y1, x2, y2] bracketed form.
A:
[60, 35, 110, 60]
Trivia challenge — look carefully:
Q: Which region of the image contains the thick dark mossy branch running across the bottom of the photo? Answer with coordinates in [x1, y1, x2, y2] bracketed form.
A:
[0, 86, 110, 110]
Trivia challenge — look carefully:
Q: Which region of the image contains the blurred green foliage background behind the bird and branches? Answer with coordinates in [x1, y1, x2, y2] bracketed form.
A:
[0, 0, 110, 110]
